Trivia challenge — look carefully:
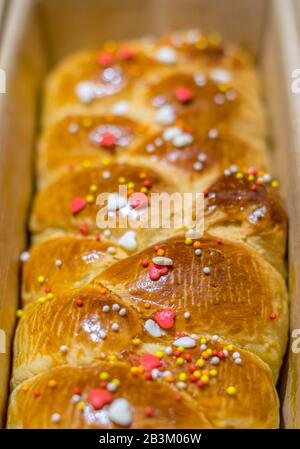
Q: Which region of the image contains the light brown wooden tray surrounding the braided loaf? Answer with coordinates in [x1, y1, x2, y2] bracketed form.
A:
[0, 0, 300, 428]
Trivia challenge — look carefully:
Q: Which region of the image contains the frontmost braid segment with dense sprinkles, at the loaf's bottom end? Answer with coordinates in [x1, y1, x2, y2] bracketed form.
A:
[8, 337, 278, 428]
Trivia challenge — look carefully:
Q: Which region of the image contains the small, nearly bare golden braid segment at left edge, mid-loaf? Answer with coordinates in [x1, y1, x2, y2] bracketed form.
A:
[22, 236, 127, 305]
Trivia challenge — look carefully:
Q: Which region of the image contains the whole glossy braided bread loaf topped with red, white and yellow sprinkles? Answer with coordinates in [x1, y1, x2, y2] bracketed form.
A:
[7, 30, 288, 428]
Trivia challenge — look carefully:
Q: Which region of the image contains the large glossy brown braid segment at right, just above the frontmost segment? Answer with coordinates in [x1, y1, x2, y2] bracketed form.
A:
[95, 236, 288, 378]
